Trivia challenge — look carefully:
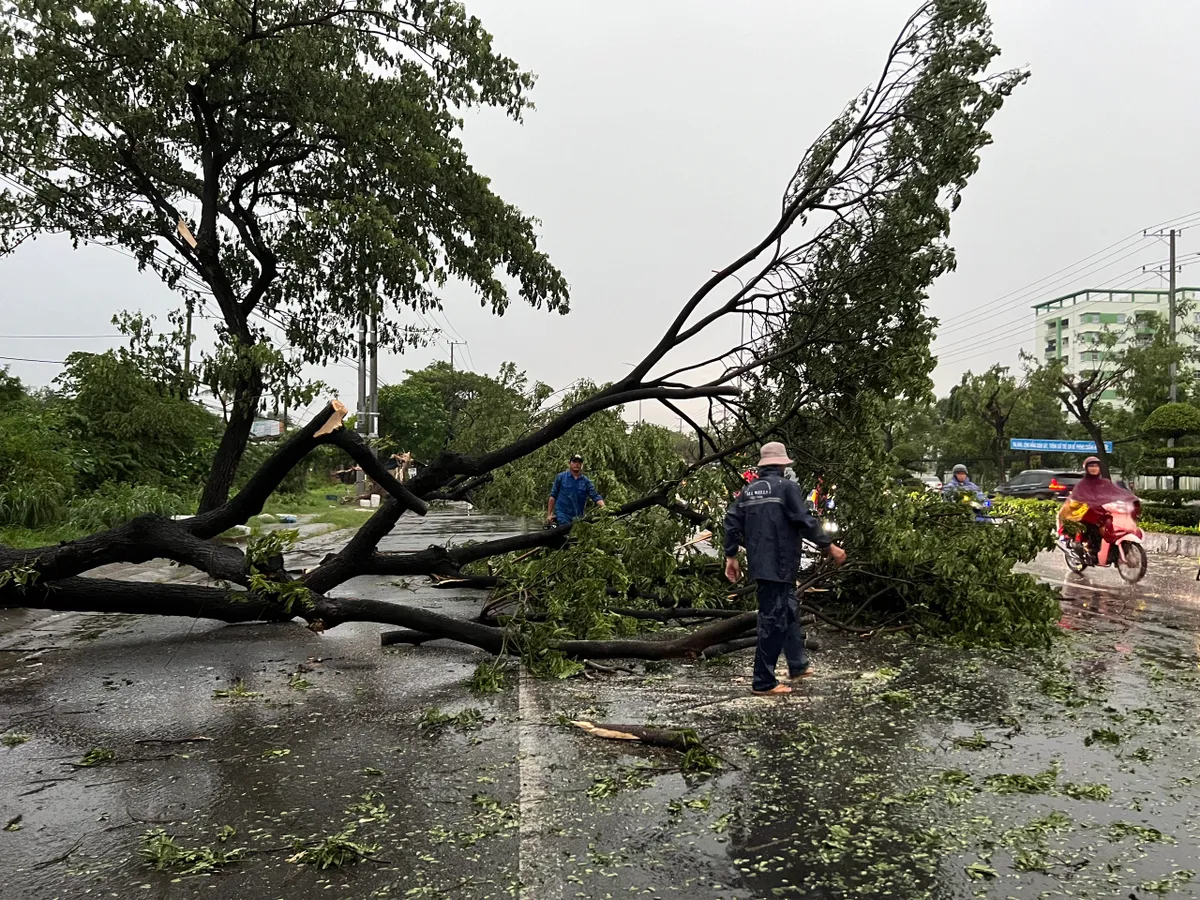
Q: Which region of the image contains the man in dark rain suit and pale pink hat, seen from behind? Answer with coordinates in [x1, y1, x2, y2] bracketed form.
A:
[725, 442, 846, 694]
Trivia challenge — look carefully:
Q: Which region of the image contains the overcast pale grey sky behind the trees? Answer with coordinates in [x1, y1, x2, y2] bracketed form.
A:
[0, 0, 1200, 421]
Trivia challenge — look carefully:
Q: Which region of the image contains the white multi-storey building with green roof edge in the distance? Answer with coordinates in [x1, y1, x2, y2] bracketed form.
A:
[1031, 288, 1200, 400]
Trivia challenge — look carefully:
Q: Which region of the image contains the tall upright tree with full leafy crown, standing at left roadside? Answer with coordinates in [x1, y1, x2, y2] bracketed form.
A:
[0, 0, 566, 511]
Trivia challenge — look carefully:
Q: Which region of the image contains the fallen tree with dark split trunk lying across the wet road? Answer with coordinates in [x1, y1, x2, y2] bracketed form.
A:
[0, 0, 1051, 664]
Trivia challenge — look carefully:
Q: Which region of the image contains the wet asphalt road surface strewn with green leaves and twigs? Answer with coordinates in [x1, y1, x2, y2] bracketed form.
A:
[0, 515, 1200, 900]
